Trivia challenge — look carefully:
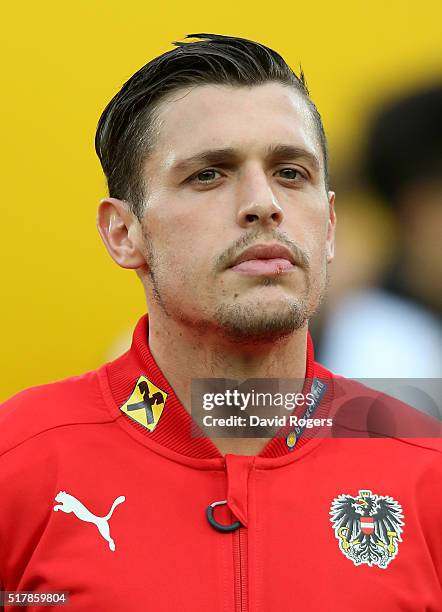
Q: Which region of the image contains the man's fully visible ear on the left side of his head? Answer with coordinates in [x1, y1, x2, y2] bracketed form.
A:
[97, 197, 146, 269]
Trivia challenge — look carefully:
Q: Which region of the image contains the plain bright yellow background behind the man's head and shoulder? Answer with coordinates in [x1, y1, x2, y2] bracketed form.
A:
[0, 0, 442, 399]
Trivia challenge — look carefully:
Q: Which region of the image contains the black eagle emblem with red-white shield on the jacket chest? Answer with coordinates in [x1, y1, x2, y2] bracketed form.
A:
[330, 490, 404, 569]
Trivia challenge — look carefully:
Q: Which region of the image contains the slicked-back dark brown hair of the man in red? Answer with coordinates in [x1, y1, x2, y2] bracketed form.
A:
[95, 34, 328, 218]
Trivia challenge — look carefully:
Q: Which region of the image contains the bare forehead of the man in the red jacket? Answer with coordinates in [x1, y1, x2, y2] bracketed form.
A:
[153, 83, 323, 169]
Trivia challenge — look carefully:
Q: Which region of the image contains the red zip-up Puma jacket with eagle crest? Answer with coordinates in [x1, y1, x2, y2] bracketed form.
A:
[0, 317, 442, 612]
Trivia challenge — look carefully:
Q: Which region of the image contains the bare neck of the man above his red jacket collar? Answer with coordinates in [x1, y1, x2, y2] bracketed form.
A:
[145, 308, 307, 455]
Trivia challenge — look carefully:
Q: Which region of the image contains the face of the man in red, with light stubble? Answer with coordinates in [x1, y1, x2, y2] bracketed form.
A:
[141, 83, 334, 341]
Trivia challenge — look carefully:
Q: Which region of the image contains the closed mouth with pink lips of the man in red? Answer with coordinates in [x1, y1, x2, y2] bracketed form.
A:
[229, 244, 296, 276]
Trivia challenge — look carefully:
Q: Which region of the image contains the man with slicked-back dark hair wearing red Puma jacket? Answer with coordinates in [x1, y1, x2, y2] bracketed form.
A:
[0, 34, 442, 612]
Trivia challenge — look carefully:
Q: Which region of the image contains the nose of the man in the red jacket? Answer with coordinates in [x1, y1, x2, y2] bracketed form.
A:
[237, 168, 284, 228]
